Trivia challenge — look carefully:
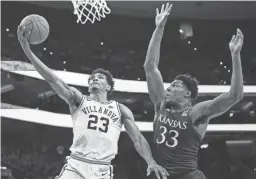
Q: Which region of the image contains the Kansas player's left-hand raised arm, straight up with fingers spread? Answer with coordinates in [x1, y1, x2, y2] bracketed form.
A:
[144, 3, 172, 107]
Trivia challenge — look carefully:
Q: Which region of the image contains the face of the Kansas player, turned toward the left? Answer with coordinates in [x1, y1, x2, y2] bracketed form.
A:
[165, 80, 188, 103]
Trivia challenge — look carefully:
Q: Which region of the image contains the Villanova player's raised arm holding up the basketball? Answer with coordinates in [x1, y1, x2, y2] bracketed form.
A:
[17, 26, 82, 105]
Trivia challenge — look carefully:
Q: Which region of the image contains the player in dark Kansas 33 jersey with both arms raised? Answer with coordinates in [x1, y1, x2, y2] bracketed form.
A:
[144, 3, 243, 179]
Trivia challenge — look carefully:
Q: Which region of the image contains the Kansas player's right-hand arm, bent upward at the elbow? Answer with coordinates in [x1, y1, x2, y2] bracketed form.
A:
[192, 29, 244, 119]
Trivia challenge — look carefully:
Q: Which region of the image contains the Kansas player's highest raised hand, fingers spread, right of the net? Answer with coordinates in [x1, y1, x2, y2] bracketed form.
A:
[156, 3, 172, 27]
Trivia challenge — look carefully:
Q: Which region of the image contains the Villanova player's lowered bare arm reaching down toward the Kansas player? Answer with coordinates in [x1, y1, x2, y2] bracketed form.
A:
[120, 104, 169, 179]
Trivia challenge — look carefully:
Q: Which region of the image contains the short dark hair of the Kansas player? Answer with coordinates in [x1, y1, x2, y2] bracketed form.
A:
[175, 74, 199, 100]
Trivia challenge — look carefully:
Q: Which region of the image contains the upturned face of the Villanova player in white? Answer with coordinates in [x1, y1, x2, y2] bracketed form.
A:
[89, 73, 110, 92]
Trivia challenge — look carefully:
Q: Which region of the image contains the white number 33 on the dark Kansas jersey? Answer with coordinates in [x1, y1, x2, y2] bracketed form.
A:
[156, 126, 179, 148]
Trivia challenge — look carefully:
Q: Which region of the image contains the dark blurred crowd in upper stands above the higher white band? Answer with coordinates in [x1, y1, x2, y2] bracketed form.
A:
[1, 2, 256, 85]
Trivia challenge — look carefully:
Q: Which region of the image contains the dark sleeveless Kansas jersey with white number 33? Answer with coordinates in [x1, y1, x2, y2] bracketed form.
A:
[154, 109, 200, 176]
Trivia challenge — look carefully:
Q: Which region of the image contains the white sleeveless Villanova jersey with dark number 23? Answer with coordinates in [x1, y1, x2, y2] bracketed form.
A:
[70, 96, 122, 163]
